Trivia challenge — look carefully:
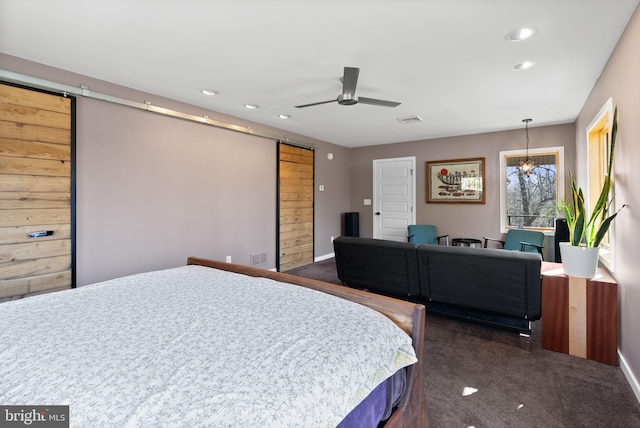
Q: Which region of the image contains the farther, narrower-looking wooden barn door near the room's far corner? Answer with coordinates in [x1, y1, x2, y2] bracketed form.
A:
[277, 143, 314, 272]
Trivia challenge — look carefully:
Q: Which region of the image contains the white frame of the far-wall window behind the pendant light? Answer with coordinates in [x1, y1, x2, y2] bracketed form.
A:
[500, 146, 565, 236]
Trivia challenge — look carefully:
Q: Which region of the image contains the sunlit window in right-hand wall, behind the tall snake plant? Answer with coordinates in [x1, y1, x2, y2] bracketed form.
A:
[585, 98, 615, 269]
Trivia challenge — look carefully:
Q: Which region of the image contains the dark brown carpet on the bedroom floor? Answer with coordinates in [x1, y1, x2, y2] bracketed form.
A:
[287, 259, 640, 428]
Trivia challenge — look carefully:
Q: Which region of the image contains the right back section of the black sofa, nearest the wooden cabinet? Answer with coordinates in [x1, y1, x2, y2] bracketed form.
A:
[417, 245, 542, 320]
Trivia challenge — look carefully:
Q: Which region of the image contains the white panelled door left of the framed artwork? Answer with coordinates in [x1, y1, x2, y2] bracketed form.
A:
[373, 157, 416, 242]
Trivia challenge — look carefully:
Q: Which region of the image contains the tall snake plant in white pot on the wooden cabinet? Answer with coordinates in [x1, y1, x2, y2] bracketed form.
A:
[560, 107, 624, 278]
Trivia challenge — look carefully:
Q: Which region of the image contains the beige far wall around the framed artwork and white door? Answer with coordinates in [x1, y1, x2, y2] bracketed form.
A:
[351, 122, 575, 260]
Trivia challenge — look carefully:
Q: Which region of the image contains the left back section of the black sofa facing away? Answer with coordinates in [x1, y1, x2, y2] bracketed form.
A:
[333, 236, 420, 298]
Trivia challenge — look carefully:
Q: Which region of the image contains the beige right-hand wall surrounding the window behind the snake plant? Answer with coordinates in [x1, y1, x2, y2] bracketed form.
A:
[576, 4, 640, 397]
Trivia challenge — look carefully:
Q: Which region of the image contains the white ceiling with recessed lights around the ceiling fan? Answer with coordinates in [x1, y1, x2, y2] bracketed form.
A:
[0, 0, 640, 147]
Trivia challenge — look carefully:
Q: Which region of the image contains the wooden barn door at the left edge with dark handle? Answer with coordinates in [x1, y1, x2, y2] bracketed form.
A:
[0, 84, 74, 302]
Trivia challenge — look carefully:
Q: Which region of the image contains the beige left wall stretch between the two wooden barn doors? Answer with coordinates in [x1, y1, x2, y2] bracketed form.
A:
[76, 98, 276, 285]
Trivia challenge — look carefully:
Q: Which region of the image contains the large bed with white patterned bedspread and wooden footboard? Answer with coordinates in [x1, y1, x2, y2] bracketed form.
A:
[0, 257, 427, 428]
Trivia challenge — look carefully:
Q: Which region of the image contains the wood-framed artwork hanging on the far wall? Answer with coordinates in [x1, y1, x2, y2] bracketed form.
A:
[425, 158, 485, 204]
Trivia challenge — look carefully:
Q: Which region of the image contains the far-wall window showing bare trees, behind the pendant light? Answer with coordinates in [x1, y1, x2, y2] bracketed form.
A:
[500, 147, 564, 232]
